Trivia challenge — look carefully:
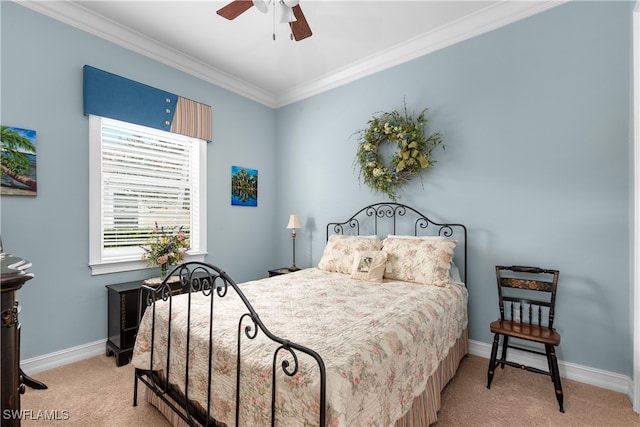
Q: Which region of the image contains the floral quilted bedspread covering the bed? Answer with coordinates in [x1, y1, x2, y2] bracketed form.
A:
[132, 268, 468, 426]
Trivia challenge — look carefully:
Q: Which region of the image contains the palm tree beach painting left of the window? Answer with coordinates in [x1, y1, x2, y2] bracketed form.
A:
[0, 126, 38, 196]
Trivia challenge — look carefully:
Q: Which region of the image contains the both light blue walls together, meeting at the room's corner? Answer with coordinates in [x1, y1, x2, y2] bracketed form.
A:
[0, 2, 632, 376]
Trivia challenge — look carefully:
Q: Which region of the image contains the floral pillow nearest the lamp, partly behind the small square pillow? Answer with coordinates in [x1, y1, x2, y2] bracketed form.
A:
[318, 234, 382, 274]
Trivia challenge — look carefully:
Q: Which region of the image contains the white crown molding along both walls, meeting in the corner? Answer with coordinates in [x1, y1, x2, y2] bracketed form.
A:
[14, 0, 570, 108]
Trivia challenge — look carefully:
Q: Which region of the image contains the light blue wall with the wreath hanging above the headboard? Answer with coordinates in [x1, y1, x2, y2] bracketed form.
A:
[277, 2, 633, 376]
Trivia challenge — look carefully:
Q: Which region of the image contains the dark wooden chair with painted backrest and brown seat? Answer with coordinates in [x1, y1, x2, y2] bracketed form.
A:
[487, 266, 564, 412]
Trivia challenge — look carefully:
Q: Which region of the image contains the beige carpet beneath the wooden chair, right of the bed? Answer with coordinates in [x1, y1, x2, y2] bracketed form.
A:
[433, 356, 640, 427]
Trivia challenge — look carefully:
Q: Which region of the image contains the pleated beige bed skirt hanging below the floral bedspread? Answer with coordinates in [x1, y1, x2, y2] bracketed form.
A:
[145, 329, 469, 427]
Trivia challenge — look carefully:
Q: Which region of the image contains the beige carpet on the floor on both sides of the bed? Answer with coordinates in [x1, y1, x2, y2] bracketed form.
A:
[21, 356, 640, 427]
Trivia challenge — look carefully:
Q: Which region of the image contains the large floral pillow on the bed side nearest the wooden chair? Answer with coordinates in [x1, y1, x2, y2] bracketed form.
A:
[382, 237, 456, 286]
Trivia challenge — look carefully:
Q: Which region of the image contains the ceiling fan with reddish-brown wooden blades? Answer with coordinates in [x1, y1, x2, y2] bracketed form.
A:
[216, 0, 313, 41]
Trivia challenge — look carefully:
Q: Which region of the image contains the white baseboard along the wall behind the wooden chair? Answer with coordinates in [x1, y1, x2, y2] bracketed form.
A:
[469, 340, 633, 401]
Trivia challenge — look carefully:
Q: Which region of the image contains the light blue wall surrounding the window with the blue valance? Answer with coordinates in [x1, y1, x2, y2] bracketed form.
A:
[0, 1, 277, 359]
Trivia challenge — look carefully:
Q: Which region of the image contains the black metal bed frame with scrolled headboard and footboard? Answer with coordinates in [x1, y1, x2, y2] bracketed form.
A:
[133, 202, 467, 426]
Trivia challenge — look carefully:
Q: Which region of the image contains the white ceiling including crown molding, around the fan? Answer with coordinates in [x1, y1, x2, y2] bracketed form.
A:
[19, 0, 566, 108]
